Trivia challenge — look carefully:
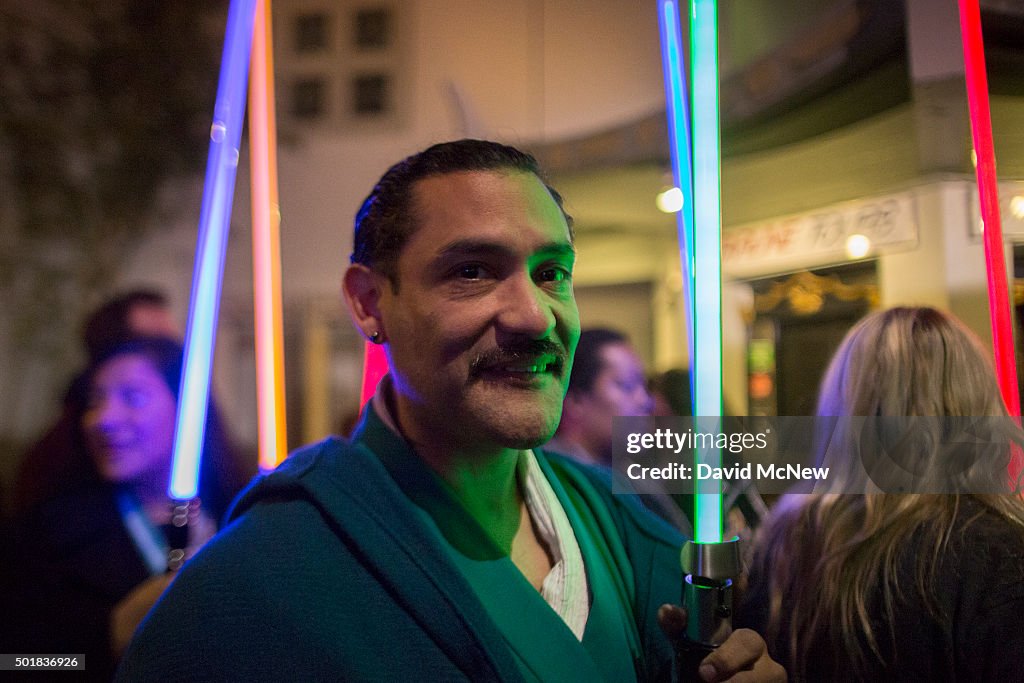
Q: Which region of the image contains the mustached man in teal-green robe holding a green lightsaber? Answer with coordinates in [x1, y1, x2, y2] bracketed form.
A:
[121, 140, 784, 681]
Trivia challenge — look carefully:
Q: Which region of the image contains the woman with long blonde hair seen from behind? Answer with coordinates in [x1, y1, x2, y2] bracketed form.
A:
[737, 307, 1024, 681]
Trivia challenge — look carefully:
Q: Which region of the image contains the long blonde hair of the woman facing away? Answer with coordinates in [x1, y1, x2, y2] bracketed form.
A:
[752, 307, 1024, 680]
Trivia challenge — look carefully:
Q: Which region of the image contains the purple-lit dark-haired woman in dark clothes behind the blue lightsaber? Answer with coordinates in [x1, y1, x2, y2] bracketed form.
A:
[0, 337, 245, 680]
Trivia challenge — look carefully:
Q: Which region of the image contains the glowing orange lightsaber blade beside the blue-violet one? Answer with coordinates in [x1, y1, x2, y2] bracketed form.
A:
[243, 0, 288, 471]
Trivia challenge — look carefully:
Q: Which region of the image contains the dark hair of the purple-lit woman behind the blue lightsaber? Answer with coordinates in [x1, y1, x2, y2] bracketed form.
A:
[78, 337, 245, 520]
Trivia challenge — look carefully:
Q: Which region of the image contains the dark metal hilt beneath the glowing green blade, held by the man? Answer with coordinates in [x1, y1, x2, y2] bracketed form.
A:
[676, 537, 739, 683]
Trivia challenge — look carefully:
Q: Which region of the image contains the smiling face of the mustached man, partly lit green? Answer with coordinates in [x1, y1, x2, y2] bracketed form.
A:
[380, 171, 580, 451]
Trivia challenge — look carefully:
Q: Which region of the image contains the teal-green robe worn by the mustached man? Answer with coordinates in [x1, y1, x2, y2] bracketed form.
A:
[119, 410, 682, 681]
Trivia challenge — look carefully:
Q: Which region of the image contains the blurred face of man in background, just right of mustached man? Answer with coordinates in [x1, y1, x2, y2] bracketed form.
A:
[573, 343, 654, 459]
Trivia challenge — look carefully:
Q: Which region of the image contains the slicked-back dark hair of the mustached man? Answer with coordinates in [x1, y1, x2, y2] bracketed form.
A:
[350, 139, 572, 290]
